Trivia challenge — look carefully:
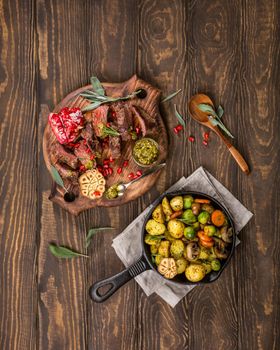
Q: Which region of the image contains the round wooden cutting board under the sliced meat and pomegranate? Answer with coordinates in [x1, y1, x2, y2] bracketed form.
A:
[43, 75, 168, 215]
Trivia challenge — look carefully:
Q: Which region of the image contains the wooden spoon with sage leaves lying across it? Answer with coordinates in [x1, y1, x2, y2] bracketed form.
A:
[189, 94, 250, 174]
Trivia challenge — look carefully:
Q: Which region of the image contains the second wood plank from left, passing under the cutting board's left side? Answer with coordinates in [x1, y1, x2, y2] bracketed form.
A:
[36, 0, 88, 349]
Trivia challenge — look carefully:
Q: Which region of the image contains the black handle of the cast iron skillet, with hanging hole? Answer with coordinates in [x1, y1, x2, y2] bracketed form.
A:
[89, 256, 150, 303]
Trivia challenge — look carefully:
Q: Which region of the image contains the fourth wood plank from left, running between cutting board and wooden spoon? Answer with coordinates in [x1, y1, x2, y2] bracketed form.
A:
[138, 0, 189, 350]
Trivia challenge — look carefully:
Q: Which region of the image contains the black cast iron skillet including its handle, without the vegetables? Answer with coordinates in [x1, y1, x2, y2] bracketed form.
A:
[89, 191, 236, 303]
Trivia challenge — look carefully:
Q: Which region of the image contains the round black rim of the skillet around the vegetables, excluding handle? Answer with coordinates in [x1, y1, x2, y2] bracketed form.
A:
[142, 190, 236, 286]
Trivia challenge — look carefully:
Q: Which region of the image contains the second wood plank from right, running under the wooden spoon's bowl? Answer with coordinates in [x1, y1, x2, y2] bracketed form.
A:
[184, 1, 240, 350]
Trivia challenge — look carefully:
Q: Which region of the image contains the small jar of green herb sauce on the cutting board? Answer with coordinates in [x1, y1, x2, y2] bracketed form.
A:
[133, 138, 159, 166]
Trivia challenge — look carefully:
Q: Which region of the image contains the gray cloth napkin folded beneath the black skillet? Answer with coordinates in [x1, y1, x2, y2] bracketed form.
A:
[112, 167, 253, 307]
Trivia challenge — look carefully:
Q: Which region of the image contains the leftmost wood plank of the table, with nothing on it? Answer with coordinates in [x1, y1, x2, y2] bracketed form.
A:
[0, 0, 38, 349]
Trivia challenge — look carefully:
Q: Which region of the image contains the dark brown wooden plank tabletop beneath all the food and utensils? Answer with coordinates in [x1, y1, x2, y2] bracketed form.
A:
[0, 0, 280, 350]
